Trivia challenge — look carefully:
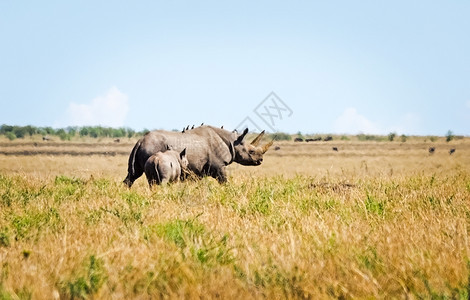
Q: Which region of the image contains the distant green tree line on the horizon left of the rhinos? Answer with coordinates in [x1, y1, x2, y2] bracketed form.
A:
[0, 124, 148, 141]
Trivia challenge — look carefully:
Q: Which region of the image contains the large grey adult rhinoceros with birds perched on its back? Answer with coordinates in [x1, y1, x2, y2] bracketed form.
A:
[124, 125, 273, 187]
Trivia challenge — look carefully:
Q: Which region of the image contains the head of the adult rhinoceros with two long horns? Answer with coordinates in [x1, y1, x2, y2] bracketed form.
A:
[233, 128, 273, 166]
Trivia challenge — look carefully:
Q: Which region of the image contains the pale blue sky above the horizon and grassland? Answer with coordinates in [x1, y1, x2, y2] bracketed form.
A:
[0, 1, 470, 135]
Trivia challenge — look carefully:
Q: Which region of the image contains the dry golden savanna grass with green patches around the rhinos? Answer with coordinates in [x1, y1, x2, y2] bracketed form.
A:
[0, 138, 470, 299]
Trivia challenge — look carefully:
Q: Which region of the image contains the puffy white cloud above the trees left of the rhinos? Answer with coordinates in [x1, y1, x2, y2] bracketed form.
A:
[61, 87, 129, 127]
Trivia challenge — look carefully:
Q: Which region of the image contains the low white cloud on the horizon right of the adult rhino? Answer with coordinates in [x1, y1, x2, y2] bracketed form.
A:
[334, 107, 381, 134]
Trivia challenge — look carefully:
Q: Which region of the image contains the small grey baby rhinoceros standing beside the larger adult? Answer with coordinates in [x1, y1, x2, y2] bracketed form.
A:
[144, 148, 189, 187]
